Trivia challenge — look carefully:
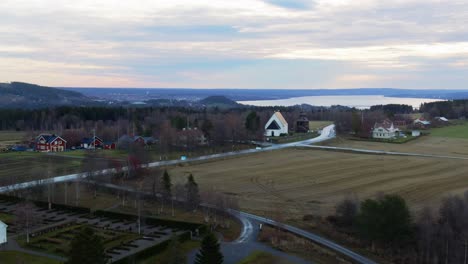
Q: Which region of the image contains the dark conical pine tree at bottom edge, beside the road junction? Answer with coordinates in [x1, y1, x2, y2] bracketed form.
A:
[195, 233, 224, 264]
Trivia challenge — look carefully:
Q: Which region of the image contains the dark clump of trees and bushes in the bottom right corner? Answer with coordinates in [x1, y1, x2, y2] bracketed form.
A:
[328, 191, 468, 264]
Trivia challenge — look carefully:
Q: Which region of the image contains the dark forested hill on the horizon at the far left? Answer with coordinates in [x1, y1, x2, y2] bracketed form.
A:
[0, 82, 92, 108]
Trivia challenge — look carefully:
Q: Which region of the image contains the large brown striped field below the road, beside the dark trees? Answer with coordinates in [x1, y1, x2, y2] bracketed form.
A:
[164, 149, 468, 220]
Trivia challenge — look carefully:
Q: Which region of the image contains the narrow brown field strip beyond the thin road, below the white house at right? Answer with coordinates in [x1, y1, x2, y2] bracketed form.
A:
[323, 136, 468, 156]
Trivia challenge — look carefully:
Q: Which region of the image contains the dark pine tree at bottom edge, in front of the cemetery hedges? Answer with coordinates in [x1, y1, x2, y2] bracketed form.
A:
[67, 227, 107, 264]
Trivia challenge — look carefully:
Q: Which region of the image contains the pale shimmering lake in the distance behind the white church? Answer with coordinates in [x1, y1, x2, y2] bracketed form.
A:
[238, 95, 443, 109]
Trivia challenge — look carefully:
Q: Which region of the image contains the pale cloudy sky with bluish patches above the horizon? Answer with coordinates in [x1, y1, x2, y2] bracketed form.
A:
[0, 0, 468, 89]
